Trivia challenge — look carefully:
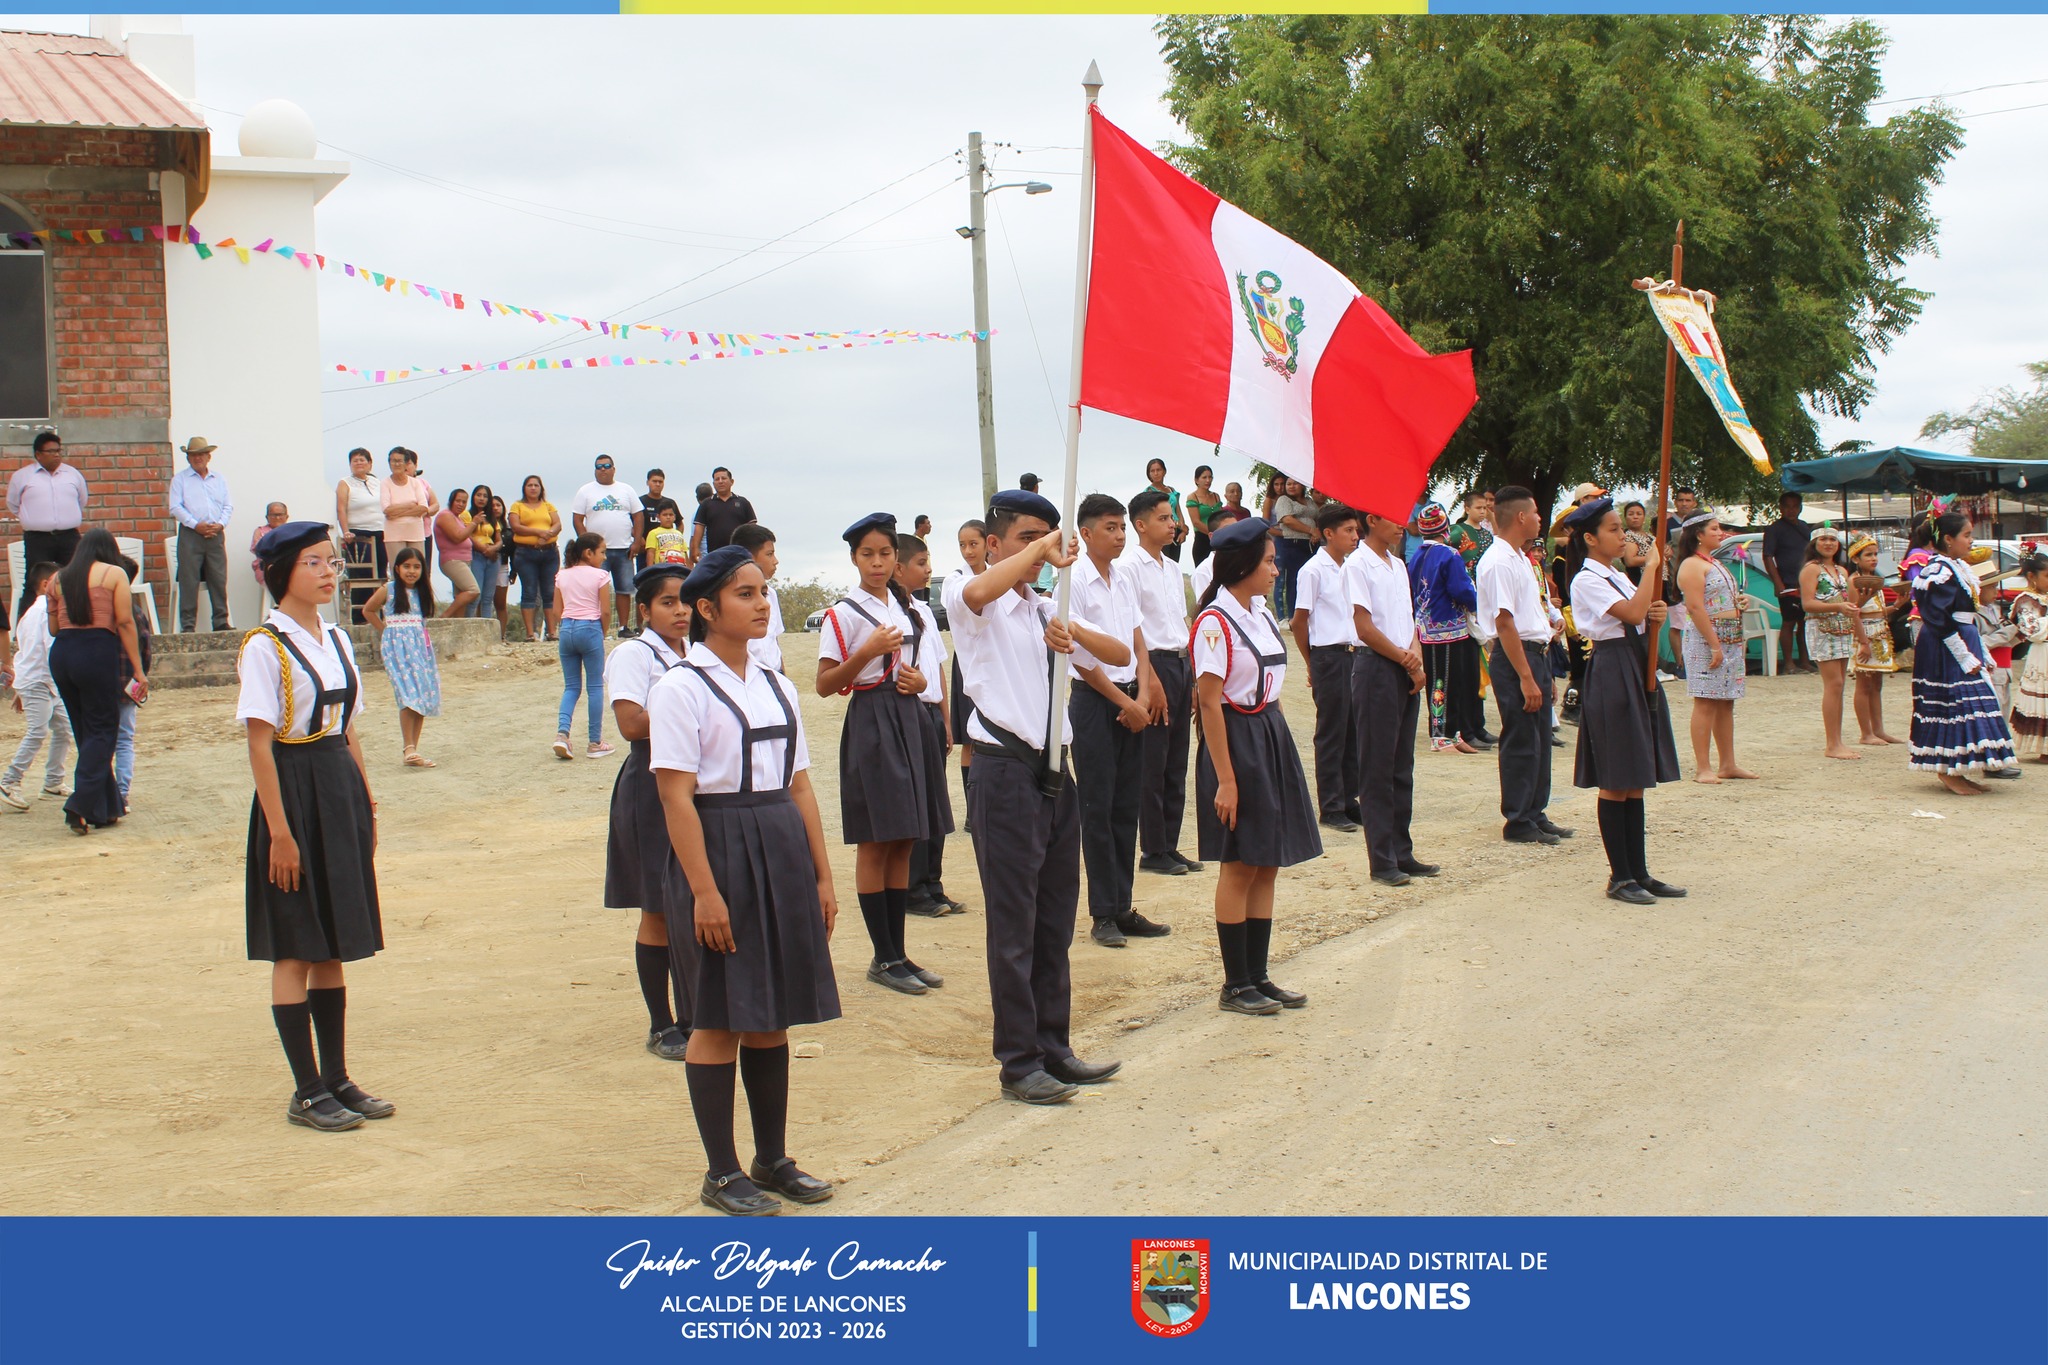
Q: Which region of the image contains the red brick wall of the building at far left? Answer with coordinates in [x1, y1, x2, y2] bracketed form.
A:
[0, 129, 174, 591]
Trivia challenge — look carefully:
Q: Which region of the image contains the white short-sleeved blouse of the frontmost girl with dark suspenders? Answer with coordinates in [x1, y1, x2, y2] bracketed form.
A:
[647, 641, 811, 796]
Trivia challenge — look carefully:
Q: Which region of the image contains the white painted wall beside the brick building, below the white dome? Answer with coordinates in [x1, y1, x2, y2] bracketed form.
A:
[163, 153, 348, 628]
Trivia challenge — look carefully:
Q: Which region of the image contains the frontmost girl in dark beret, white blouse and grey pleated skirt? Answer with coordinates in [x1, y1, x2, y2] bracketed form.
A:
[647, 544, 840, 1216]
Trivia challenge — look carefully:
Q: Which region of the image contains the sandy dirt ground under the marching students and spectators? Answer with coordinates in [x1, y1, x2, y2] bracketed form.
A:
[0, 634, 2048, 1216]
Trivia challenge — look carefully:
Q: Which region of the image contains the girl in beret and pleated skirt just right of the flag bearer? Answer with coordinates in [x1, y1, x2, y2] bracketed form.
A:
[1192, 518, 1323, 1015]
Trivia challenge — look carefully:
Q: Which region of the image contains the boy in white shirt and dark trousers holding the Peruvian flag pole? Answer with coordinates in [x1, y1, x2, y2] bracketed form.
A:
[946, 489, 1130, 1105]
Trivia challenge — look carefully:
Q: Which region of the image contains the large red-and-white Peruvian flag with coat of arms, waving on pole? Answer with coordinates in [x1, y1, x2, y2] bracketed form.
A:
[1081, 111, 1479, 522]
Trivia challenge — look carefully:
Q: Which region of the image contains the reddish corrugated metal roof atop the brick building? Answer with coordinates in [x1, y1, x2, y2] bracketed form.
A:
[0, 31, 207, 131]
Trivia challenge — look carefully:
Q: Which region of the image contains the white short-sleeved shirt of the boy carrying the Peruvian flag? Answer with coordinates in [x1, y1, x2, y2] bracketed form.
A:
[946, 573, 1100, 749]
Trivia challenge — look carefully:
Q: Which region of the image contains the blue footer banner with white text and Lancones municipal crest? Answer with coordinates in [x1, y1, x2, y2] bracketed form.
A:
[0, 1218, 2048, 1365]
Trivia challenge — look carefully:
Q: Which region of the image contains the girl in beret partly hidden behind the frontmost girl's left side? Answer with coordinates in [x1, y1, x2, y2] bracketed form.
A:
[604, 561, 690, 1062]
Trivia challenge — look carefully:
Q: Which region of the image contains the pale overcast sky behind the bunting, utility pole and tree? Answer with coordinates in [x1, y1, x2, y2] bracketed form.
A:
[16, 16, 2048, 581]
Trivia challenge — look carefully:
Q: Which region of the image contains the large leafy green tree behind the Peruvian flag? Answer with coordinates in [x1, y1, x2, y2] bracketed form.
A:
[1157, 14, 1962, 517]
